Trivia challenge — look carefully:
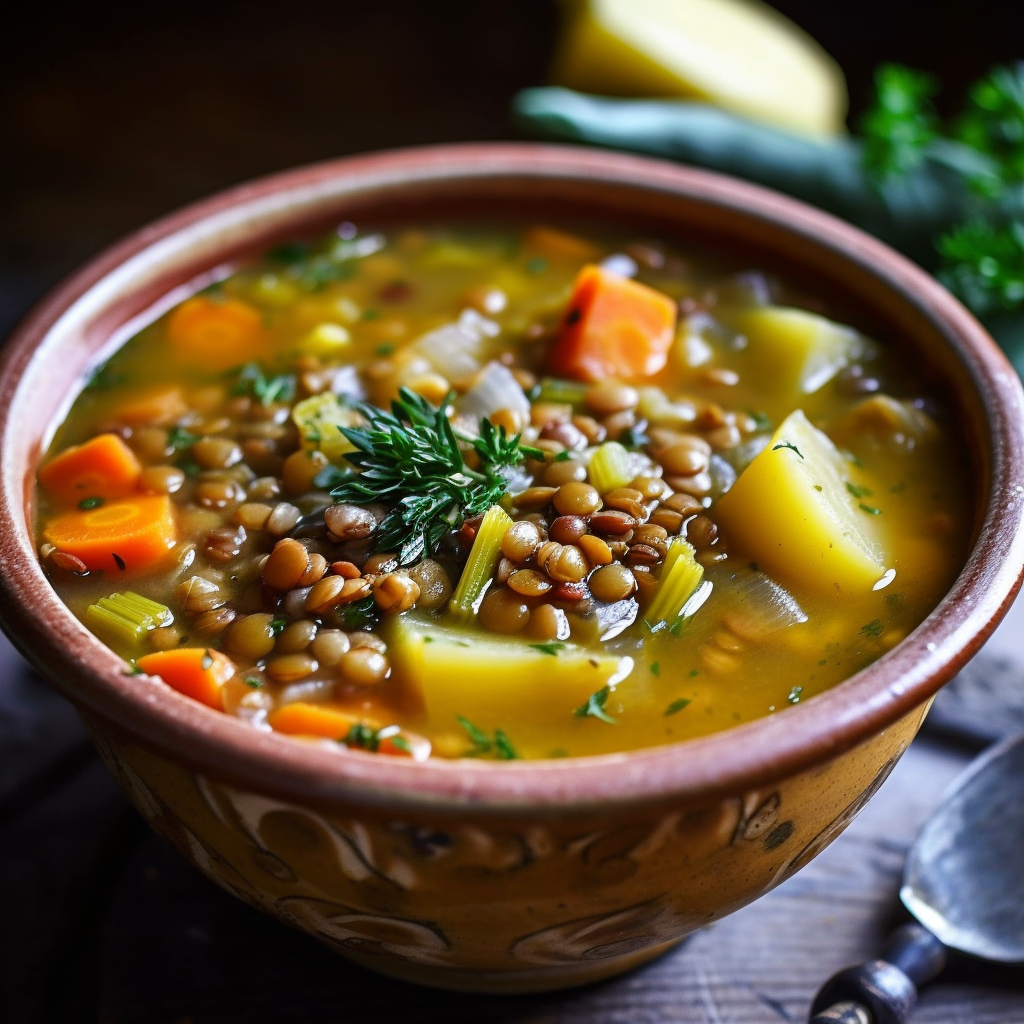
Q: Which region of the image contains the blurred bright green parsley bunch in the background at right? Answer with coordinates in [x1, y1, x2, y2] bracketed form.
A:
[860, 62, 1024, 316]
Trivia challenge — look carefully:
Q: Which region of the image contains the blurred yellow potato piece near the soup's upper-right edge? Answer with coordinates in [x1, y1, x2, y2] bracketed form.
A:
[722, 306, 873, 409]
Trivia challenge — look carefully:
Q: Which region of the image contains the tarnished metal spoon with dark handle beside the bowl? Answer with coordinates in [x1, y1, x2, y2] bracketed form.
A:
[811, 734, 1024, 1024]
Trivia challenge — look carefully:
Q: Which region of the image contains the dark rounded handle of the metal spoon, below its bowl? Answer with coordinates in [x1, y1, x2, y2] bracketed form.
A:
[811, 924, 946, 1024]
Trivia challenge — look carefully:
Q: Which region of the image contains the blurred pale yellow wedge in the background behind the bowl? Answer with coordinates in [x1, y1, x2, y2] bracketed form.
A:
[552, 0, 847, 134]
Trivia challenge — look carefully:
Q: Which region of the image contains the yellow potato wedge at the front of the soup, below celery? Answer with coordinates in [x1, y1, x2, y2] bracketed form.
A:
[387, 616, 633, 735]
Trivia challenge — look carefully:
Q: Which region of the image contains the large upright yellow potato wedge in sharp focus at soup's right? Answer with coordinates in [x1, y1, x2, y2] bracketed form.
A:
[715, 410, 891, 595]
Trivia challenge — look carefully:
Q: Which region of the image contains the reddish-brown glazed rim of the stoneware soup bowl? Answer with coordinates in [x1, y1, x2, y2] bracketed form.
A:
[0, 142, 1024, 813]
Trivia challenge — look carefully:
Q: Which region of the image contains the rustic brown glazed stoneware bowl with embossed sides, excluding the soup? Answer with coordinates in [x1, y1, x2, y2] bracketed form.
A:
[0, 145, 1024, 991]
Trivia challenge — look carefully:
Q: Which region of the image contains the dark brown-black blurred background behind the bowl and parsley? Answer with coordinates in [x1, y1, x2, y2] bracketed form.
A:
[6, 0, 1024, 344]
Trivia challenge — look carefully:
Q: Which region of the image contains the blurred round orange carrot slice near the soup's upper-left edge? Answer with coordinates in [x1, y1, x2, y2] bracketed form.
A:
[167, 295, 264, 371]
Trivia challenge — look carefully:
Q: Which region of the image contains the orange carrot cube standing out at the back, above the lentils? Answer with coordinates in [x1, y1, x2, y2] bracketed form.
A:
[548, 264, 676, 381]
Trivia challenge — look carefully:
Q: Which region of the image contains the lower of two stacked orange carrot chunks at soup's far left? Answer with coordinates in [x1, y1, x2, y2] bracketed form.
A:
[43, 495, 177, 573]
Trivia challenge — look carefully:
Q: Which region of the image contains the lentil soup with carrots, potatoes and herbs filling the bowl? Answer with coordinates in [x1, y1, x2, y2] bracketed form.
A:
[38, 223, 970, 759]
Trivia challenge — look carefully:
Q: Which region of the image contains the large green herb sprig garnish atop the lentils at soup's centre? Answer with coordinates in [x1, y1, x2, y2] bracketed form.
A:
[331, 388, 543, 565]
